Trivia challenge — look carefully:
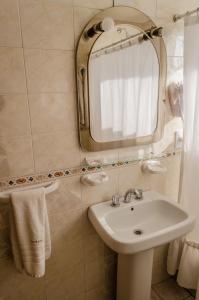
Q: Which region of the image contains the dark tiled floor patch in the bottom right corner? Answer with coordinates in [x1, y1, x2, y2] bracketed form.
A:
[151, 278, 195, 300]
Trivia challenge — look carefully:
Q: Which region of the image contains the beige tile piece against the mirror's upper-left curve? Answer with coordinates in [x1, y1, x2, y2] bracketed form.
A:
[74, 7, 100, 41]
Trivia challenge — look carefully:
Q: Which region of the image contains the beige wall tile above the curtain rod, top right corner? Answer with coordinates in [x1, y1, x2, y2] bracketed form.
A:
[157, 0, 198, 20]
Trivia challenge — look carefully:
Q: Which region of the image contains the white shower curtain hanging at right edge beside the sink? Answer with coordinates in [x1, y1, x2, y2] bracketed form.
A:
[167, 16, 199, 300]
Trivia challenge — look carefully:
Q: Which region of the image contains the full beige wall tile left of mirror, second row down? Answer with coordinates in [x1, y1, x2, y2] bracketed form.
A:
[25, 49, 75, 93]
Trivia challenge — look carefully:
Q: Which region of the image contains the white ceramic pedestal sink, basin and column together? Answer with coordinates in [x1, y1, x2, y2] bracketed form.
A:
[88, 191, 194, 300]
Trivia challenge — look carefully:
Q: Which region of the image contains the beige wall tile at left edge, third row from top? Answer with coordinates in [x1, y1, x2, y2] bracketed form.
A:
[0, 94, 30, 136]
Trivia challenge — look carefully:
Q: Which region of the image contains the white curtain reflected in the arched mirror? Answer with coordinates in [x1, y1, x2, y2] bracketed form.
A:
[89, 39, 159, 142]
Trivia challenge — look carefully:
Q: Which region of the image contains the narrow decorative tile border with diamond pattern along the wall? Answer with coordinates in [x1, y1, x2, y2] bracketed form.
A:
[0, 152, 175, 191]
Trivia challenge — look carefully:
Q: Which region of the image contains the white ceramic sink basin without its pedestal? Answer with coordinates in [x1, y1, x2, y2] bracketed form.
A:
[88, 191, 194, 254]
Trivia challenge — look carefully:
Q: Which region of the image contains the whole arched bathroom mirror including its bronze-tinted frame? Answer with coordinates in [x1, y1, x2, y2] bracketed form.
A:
[76, 7, 166, 151]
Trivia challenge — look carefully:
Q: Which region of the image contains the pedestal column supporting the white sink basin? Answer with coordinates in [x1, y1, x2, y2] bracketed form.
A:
[117, 249, 153, 300]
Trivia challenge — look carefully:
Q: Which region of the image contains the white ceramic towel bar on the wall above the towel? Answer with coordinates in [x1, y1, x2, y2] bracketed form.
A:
[0, 181, 59, 199]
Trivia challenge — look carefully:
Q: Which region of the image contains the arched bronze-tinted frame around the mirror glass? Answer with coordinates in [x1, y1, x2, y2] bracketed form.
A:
[76, 6, 167, 151]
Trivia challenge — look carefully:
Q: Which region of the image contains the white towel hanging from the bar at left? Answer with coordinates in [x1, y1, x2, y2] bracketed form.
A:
[10, 188, 51, 277]
